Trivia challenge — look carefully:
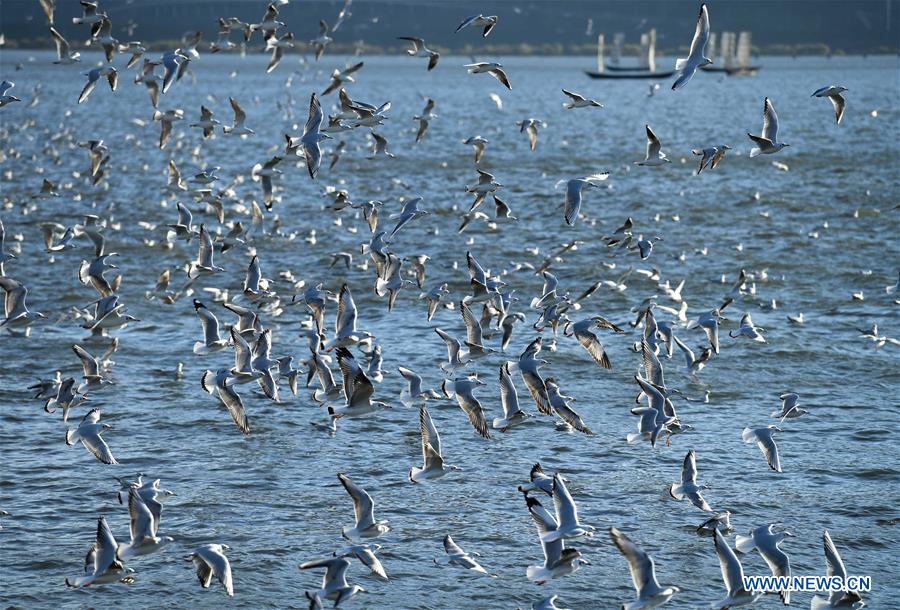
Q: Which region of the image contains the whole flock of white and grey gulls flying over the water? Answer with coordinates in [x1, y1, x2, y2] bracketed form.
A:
[0, 0, 888, 610]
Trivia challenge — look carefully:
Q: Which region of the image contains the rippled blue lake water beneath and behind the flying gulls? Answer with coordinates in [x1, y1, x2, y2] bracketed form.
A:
[0, 50, 900, 609]
